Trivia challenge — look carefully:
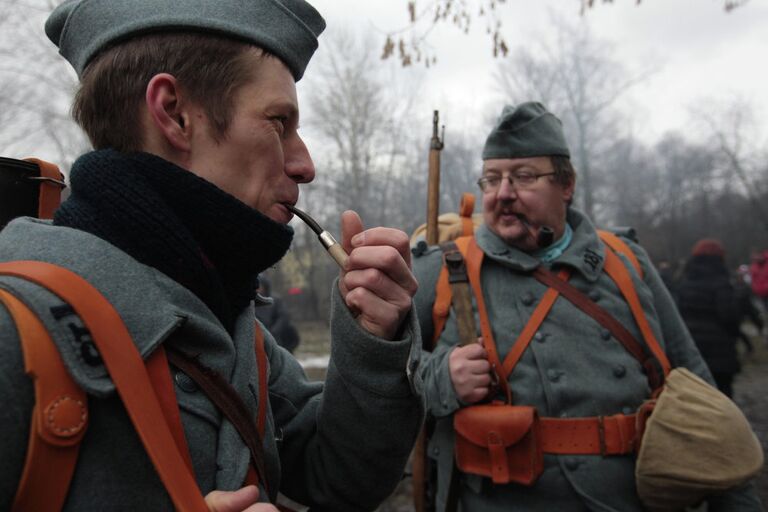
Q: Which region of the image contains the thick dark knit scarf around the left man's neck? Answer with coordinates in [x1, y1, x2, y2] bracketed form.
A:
[53, 150, 293, 333]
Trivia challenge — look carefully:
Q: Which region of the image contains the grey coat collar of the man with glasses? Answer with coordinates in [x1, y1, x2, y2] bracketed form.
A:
[475, 208, 605, 282]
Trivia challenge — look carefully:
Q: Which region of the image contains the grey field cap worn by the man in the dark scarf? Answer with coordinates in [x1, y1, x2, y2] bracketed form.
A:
[45, 0, 325, 81]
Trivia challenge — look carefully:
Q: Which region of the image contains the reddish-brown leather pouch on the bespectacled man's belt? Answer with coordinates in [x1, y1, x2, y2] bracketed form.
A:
[453, 404, 544, 485]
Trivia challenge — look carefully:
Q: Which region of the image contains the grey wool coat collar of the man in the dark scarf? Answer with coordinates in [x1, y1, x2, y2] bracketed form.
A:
[0, 218, 234, 396]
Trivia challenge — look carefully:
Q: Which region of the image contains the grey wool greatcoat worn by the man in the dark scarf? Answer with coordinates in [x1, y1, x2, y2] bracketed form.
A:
[0, 219, 423, 511]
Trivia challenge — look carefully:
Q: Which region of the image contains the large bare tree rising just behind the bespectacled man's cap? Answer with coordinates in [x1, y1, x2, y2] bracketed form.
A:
[496, 15, 648, 222]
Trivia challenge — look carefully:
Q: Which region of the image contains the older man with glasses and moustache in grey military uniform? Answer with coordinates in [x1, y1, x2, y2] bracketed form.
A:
[414, 103, 760, 512]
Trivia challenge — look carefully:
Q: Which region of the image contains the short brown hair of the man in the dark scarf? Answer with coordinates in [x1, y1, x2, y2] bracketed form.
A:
[72, 32, 271, 152]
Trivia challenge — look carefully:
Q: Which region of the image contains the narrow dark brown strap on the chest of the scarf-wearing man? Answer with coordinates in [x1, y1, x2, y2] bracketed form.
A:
[167, 347, 269, 492]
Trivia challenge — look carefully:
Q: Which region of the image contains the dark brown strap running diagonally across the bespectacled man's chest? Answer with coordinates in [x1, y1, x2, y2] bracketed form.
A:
[533, 266, 664, 390]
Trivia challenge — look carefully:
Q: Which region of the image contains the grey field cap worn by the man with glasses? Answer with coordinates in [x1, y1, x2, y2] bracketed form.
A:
[483, 101, 571, 160]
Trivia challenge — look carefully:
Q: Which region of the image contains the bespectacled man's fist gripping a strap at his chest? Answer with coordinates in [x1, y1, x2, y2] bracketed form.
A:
[448, 339, 491, 404]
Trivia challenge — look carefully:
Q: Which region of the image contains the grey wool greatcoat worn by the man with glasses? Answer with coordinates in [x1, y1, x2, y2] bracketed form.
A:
[414, 209, 760, 512]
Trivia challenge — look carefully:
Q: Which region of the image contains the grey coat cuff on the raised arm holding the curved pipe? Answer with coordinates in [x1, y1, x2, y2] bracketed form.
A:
[329, 281, 423, 398]
